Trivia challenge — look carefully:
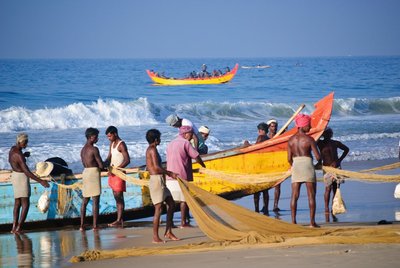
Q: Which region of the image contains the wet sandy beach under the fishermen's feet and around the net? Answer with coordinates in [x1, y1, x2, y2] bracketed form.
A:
[0, 159, 400, 268]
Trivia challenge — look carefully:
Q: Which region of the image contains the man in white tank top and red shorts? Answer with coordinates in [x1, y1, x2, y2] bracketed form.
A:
[105, 126, 131, 227]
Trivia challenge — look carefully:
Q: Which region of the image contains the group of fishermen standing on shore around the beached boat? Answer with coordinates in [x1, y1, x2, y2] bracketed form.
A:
[9, 111, 349, 239]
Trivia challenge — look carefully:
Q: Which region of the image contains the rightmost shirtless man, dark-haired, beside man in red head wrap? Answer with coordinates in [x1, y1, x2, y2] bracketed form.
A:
[317, 128, 349, 222]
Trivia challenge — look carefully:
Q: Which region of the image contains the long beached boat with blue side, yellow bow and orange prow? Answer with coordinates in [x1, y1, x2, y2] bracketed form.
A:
[0, 93, 334, 232]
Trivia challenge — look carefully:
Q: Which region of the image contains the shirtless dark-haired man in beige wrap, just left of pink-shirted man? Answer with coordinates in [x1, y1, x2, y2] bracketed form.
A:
[146, 129, 179, 243]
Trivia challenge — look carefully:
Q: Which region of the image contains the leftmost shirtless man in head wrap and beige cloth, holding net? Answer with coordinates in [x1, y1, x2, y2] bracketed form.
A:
[8, 133, 50, 234]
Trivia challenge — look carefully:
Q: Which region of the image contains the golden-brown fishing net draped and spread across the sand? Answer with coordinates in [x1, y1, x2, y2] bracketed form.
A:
[70, 177, 400, 262]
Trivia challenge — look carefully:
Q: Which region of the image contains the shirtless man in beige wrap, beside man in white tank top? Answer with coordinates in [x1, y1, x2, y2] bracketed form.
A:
[79, 128, 103, 231]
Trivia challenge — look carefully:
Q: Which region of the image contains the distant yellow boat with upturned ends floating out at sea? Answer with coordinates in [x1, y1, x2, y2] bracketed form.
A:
[146, 63, 239, 86]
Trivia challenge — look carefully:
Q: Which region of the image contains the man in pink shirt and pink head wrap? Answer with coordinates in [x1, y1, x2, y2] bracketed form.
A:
[167, 126, 206, 227]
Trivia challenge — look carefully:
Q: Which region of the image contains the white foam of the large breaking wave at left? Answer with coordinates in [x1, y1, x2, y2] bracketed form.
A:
[0, 98, 157, 132]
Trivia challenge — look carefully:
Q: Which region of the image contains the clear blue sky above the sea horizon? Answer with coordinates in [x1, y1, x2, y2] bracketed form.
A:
[0, 0, 400, 59]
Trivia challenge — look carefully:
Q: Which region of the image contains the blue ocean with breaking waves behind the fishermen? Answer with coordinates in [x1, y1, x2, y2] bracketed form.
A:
[0, 57, 400, 172]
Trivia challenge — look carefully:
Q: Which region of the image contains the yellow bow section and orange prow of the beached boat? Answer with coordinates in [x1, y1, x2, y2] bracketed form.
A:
[193, 92, 334, 199]
